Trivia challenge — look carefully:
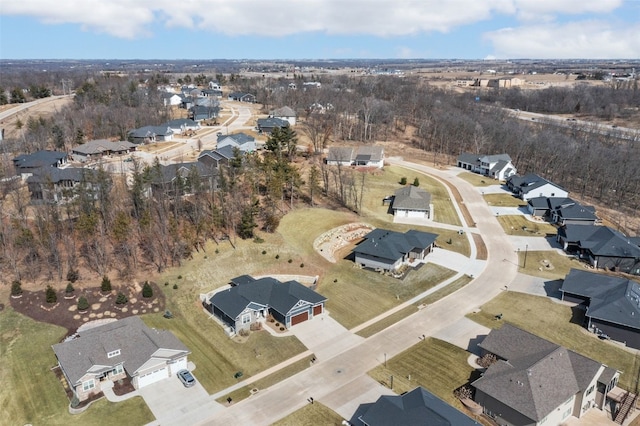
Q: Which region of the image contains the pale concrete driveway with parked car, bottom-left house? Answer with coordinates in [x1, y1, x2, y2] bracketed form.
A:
[138, 372, 211, 425]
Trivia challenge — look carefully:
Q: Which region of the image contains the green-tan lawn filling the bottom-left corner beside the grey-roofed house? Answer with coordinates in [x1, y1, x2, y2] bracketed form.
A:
[0, 307, 154, 425]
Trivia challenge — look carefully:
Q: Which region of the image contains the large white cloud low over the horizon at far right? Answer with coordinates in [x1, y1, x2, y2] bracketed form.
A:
[484, 21, 640, 59]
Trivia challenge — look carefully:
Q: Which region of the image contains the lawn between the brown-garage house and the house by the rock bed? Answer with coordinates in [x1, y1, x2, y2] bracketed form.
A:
[318, 260, 455, 329]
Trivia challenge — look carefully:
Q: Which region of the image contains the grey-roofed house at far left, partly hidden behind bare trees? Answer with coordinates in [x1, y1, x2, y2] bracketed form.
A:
[27, 167, 95, 204]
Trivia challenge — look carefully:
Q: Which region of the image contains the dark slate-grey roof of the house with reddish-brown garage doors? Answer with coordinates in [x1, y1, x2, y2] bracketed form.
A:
[209, 277, 327, 318]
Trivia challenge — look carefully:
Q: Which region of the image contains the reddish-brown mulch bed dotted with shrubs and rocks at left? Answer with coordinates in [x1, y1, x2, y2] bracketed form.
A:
[11, 282, 165, 335]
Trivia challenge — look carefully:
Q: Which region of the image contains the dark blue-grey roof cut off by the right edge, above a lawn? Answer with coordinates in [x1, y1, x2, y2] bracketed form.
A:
[560, 269, 640, 330]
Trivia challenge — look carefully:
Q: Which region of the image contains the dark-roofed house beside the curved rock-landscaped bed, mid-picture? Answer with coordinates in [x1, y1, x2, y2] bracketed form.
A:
[353, 228, 438, 272]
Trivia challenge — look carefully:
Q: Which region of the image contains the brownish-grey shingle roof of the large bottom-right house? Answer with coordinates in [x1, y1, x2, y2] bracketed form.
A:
[472, 324, 602, 422]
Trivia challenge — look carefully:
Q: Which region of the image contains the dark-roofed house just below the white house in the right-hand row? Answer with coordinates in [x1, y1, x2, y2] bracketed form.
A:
[527, 197, 598, 226]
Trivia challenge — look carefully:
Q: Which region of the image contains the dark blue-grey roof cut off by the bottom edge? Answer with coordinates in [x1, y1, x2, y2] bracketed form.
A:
[359, 387, 477, 426]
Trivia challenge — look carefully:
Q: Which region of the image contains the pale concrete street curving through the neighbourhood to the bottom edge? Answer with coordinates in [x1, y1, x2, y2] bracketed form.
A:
[161, 159, 517, 425]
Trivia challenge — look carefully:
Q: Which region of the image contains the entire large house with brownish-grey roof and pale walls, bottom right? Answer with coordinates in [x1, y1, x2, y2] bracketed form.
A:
[471, 324, 620, 426]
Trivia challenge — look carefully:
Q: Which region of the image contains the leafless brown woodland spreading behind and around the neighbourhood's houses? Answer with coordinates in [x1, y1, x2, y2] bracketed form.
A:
[0, 70, 640, 281]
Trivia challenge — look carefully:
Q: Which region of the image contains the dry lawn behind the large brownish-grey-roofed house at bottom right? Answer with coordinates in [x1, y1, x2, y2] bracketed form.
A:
[467, 291, 637, 389]
